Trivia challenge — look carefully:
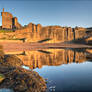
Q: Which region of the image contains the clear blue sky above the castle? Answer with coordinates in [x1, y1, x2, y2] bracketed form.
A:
[0, 0, 92, 27]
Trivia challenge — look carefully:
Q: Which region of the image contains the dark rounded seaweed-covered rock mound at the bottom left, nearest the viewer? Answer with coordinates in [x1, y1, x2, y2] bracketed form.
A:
[0, 68, 46, 92]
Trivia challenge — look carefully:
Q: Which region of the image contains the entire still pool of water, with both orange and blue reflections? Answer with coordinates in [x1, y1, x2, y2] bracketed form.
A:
[2, 49, 92, 92]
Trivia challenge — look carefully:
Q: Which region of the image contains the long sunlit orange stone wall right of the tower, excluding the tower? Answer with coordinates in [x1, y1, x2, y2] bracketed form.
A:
[16, 23, 86, 43]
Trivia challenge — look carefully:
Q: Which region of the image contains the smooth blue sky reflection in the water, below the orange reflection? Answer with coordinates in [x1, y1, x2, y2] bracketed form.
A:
[34, 49, 92, 92]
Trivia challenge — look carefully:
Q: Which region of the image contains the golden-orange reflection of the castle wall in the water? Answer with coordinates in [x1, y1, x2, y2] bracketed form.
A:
[4, 49, 91, 69]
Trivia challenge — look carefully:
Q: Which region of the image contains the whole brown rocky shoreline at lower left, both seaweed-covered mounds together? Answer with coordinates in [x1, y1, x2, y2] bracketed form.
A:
[0, 51, 46, 92]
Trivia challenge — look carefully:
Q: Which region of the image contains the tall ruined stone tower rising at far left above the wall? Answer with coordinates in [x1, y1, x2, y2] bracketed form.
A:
[1, 8, 22, 29]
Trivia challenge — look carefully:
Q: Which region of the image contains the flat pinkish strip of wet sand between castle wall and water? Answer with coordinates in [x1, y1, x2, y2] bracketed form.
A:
[0, 42, 92, 51]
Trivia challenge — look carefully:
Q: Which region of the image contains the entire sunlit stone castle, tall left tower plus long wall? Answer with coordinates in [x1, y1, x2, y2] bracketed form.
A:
[1, 9, 86, 43]
